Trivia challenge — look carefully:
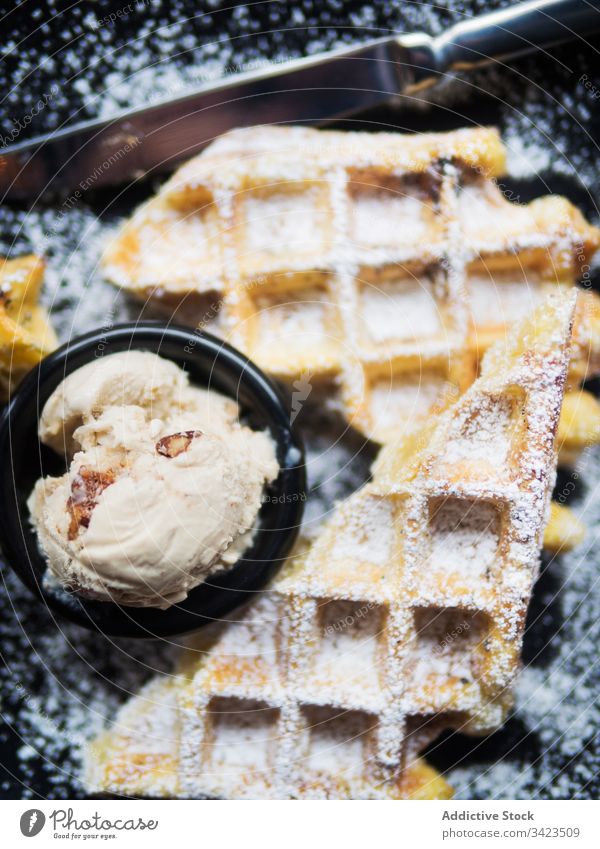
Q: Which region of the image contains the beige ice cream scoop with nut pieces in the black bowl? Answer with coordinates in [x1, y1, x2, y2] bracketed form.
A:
[28, 351, 279, 608]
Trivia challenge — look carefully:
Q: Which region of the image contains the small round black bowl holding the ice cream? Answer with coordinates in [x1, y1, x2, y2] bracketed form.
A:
[0, 322, 305, 637]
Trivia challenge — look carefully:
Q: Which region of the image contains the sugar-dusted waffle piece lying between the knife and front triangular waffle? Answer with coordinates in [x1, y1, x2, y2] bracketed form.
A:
[104, 127, 600, 447]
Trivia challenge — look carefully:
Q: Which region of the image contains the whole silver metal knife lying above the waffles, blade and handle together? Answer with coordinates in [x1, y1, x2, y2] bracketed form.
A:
[0, 0, 600, 202]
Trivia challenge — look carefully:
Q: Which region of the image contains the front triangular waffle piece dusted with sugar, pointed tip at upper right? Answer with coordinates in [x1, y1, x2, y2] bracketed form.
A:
[87, 292, 575, 798]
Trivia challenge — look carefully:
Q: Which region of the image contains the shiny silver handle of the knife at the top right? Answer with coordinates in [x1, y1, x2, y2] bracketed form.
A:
[432, 0, 600, 72]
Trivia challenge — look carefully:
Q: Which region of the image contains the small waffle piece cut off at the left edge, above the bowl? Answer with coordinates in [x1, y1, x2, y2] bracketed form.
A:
[0, 255, 57, 400]
